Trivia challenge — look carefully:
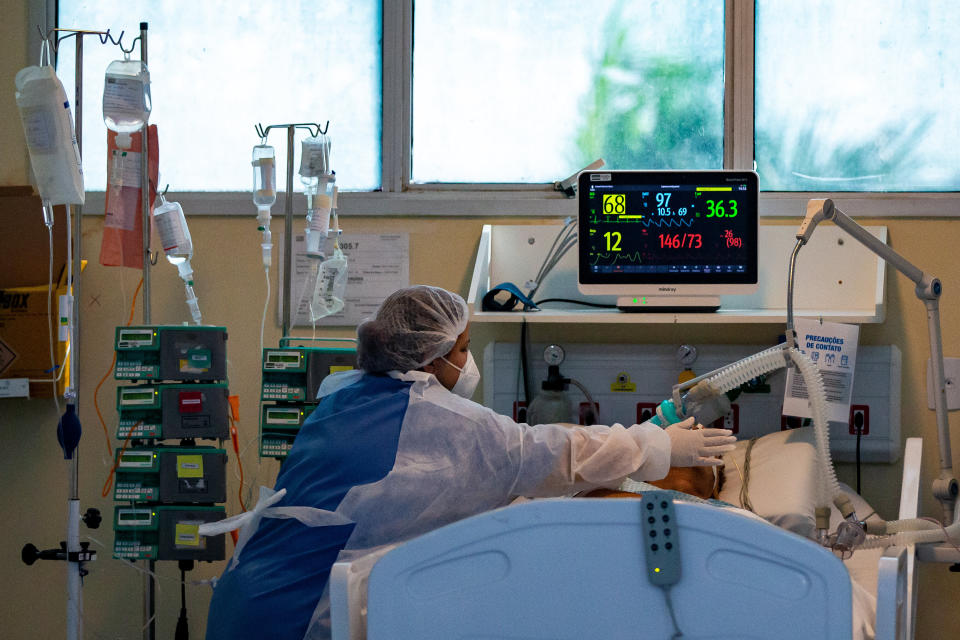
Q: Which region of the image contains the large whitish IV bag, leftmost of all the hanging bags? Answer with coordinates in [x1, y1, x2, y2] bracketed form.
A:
[14, 66, 84, 204]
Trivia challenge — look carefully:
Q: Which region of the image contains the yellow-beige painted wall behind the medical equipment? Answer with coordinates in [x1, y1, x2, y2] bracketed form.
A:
[0, 6, 960, 639]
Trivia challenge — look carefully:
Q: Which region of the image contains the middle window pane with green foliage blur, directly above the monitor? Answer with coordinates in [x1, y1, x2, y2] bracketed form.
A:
[412, 0, 724, 183]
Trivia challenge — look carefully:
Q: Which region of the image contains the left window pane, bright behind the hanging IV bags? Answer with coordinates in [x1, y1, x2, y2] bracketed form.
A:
[58, 0, 381, 191]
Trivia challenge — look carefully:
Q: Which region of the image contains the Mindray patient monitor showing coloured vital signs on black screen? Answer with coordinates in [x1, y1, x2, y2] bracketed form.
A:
[577, 171, 758, 312]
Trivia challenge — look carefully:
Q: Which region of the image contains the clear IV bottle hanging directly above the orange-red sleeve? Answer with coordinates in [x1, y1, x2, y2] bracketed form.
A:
[103, 60, 151, 149]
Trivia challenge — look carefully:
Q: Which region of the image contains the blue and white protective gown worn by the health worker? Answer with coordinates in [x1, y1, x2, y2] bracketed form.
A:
[206, 371, 670, 640]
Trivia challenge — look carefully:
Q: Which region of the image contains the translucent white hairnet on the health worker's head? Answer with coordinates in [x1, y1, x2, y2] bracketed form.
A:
[357, 285, 469, 373]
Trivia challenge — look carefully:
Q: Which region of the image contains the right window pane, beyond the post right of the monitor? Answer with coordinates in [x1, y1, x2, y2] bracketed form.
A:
[755, 0, 960, 191]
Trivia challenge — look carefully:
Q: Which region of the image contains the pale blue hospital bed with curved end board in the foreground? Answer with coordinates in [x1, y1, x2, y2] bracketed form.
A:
[330, 438, 921, 640]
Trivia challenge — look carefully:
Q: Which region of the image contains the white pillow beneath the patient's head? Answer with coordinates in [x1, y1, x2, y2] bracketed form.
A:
[720, 427, 818, 539]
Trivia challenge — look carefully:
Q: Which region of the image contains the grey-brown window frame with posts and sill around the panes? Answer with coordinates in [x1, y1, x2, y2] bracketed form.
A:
[43, 0, 960, 217]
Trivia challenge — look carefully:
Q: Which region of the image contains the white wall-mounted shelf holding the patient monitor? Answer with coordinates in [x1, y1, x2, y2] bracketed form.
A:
[467, 224, 887, 324]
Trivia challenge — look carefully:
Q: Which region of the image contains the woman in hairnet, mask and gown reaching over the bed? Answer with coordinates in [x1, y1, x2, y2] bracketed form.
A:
[206, 286, 735, 640]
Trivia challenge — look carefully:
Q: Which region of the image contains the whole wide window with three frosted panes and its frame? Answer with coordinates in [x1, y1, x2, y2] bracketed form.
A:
[41, 0, 960, 215]
